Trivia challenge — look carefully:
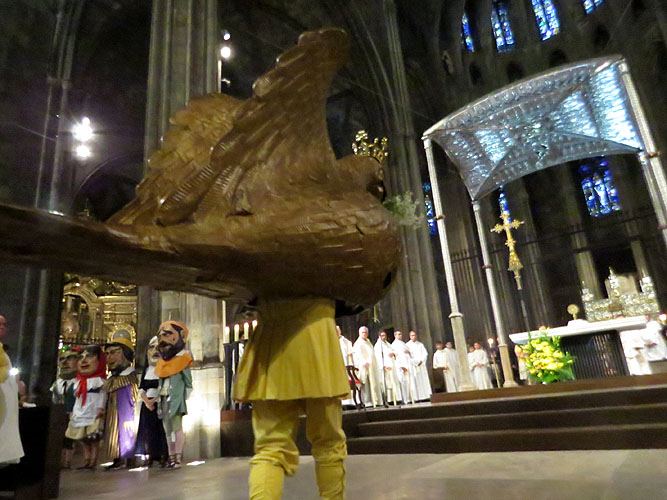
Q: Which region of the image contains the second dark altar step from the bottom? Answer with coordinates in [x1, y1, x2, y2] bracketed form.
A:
[358, 403, 667, 437]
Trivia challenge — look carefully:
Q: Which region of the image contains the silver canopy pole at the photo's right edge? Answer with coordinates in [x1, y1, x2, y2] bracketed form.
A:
[619, 61, 667, 249]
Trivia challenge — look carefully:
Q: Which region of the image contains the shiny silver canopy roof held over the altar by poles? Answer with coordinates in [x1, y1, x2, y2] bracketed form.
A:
[423, 56, 643, 200]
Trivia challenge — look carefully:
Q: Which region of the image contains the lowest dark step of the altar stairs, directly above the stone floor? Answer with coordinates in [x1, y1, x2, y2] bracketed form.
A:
[347, 423, 667, 454]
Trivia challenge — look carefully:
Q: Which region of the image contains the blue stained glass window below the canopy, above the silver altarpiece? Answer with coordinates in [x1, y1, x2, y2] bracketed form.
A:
[579, 156, 621, 217]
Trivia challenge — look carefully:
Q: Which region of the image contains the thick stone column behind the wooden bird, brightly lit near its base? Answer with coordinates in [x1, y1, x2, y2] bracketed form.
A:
[144, 0, 225, 460]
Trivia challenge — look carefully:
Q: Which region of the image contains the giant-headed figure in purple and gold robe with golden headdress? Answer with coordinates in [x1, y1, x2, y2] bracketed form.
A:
[104, 330, 139, 470]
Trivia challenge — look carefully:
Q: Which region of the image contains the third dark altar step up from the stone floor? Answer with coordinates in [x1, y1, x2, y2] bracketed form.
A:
[358, 385, 667, 422]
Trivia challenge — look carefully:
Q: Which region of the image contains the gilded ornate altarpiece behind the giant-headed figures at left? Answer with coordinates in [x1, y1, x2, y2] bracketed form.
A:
[60, 275, 137, 346]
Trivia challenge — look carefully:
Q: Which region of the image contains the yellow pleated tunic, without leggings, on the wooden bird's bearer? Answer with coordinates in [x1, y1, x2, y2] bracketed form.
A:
[234, 297, 350, 401]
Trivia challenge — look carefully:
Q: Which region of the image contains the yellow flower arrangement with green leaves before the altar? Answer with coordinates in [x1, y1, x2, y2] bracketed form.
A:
[521, 328, 574, 384]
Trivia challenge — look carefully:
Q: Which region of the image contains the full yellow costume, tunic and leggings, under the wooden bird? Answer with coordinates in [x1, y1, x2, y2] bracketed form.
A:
[234, 298, 349, 500]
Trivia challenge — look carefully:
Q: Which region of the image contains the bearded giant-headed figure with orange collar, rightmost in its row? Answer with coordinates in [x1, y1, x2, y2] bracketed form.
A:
[155, 321, 192, 469]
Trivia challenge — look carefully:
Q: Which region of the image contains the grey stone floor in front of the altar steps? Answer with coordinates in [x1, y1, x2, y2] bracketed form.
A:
[60, 450, 667, 500]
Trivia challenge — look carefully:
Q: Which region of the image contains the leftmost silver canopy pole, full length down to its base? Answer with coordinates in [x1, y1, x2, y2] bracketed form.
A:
[423, 138, 477, 391]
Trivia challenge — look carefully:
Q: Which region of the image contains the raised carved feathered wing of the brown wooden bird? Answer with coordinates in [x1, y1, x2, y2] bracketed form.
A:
[110, 29, 349, 225]
